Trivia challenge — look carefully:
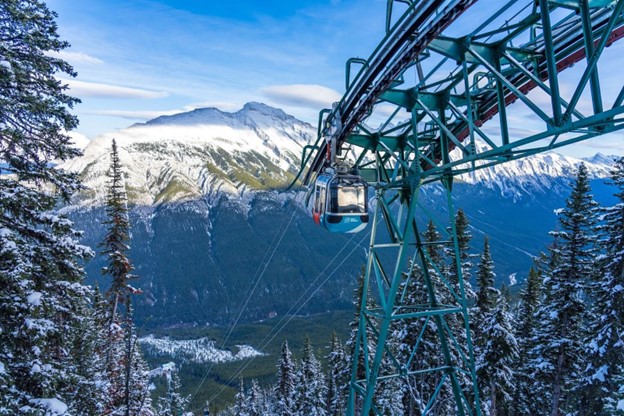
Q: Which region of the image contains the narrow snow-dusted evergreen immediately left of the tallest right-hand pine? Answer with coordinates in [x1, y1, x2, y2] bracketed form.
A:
[511, 267, 542, 415]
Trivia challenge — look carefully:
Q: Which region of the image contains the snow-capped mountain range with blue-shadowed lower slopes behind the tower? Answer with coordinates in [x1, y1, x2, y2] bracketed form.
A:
[62, 103, 610, 326]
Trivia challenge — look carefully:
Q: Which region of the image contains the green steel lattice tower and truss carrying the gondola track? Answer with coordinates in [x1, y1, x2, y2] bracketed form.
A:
[300, 0, 624, 415]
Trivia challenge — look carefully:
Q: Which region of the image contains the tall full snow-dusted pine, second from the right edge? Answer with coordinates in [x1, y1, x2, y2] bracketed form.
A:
[531, 164, 596, 416]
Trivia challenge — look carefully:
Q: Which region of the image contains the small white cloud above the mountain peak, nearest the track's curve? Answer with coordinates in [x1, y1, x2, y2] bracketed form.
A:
[260, 84, 342, 109]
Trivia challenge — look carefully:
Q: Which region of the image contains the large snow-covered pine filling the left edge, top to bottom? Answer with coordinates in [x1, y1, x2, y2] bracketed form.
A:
[0, 0, 97, 415]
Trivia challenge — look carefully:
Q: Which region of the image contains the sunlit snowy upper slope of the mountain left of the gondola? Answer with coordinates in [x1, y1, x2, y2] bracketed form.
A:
[61, 103, 315, 205]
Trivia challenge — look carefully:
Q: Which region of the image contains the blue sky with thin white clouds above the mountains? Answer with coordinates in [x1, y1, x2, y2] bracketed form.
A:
[47, 0, 624, 156]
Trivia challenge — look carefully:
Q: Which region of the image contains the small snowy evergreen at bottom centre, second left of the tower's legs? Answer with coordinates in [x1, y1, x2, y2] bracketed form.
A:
[295, 337, 327, 416]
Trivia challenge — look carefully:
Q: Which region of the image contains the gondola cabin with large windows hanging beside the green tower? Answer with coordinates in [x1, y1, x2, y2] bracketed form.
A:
[312, 172, 368, 233]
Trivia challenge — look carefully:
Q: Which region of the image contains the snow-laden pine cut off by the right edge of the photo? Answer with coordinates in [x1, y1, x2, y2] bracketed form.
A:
[577, 158, 624, 415]
